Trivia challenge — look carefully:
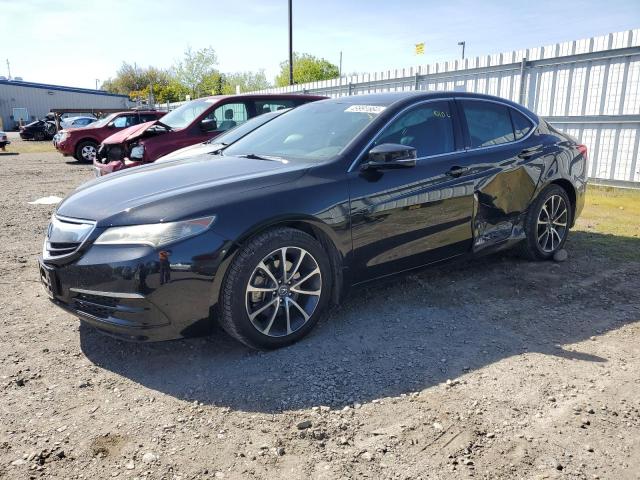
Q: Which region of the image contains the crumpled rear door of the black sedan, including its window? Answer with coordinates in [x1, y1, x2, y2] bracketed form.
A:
[457, 98, 546, 251]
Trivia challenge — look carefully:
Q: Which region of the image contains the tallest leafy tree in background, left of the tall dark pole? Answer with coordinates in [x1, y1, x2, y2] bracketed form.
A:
[174, 47, 222, 98]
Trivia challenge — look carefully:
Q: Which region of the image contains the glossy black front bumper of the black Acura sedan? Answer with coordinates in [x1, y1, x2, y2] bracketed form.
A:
[38, 231, 227, 341]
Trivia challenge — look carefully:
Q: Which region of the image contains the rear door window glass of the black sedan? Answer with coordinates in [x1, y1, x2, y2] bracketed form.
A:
[461, 100, 515, 148]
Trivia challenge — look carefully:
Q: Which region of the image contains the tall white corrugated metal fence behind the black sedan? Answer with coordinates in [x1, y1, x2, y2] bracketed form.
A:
[252, 29, 640, 186]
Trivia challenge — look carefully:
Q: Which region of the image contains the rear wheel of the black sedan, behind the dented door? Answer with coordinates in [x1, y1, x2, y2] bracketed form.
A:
[520, 184, 573, 260]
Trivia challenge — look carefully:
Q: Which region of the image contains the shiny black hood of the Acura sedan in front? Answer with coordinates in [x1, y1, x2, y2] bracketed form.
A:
[56, 154, 311, 227]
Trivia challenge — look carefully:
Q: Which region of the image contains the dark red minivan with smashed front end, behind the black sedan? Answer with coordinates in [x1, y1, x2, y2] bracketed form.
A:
[93, 95, 326, 176]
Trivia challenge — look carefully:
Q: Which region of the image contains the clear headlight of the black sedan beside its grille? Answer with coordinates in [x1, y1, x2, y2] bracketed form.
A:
[94, 215, 216, 247]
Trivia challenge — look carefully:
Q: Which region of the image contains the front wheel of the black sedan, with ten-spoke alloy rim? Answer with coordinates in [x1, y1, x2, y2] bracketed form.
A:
[220, 228, 333, 349]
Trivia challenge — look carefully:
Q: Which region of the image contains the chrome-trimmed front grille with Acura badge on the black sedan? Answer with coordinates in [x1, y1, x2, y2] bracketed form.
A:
[42, 215, 95, 259]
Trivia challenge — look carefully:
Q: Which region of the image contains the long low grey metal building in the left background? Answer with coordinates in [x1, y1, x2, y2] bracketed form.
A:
[0, 81, 129, 130]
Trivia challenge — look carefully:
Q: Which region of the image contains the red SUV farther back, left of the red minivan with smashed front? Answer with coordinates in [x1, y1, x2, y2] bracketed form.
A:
[54, 110, 166, 162]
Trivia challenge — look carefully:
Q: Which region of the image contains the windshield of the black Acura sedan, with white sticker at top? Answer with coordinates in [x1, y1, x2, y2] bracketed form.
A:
[224, 101, 384, 162]
